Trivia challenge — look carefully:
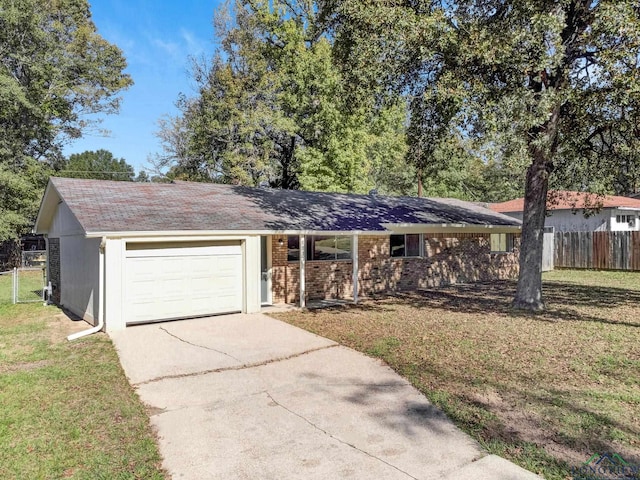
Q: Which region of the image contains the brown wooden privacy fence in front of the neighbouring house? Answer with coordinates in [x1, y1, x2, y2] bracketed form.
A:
[554, 232, 640, 270]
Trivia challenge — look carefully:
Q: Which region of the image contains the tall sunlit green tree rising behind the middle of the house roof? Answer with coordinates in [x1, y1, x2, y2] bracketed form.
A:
[154, 1, 411, 192]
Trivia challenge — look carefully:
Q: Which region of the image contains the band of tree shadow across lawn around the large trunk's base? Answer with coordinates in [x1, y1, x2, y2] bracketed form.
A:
[312, 281, 640, 327]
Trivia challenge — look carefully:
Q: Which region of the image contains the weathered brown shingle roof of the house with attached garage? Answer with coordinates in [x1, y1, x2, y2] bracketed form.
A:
[41, 178, 520, 233]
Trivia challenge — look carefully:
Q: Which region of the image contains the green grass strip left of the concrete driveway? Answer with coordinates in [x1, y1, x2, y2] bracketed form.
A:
[0, 303, 165, 479]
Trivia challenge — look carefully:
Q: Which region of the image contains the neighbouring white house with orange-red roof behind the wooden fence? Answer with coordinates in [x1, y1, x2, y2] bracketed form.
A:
[489, 191, 640, 232]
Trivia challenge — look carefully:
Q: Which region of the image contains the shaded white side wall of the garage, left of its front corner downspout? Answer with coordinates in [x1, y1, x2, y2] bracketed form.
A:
[60, 235, 100, 325]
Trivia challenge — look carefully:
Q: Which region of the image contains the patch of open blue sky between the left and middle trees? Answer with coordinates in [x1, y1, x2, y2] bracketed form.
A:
[64, 0, 219, 172]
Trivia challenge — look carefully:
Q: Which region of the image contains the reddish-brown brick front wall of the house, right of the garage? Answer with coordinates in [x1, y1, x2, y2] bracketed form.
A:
[272, 234, 520, 303]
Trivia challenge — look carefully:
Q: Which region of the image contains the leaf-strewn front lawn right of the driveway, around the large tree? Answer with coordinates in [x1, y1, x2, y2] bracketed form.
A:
[274, 270, 640, 479]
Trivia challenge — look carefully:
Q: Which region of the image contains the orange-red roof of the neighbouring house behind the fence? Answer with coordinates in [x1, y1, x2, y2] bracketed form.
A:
[489, 190, 640, 213]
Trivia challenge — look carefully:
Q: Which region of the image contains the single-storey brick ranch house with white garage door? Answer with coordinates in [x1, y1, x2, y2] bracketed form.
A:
[35, 178, 520, 331]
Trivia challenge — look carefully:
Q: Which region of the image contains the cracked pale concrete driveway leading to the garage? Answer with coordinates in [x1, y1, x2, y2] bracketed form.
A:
[111, 314, 539, 480]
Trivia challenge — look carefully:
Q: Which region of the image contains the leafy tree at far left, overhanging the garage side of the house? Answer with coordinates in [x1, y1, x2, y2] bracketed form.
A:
[0, 0, 132, 240]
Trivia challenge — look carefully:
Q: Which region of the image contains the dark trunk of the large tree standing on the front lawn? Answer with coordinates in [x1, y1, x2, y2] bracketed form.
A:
[513, 148, 549, 311]
